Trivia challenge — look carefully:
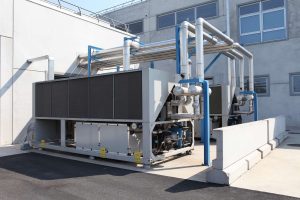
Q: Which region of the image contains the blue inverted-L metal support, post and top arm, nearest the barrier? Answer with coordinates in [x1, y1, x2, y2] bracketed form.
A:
[179, 78, 210, 166]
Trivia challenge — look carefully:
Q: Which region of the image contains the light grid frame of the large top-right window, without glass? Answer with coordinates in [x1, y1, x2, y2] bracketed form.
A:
[237, 0, 288, 46]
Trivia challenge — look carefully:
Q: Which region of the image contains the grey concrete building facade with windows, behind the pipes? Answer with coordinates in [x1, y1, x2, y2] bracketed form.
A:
[105, 0, 300, 127]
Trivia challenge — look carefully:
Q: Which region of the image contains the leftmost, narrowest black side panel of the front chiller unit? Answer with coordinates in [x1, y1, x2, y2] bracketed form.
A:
[35, 83, 51, 117]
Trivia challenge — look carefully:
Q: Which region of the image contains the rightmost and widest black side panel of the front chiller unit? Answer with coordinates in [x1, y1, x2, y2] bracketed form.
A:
[114, 71, 143, 119]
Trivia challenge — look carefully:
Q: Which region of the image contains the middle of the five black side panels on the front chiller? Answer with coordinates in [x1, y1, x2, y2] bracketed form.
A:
[69, 78, 89, 118]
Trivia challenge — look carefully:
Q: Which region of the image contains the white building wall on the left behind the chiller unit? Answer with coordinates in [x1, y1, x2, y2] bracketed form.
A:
[0, 0, 129, 144]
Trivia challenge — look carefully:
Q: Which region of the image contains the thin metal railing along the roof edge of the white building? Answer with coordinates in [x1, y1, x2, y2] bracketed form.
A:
[41, 0, 129, 32]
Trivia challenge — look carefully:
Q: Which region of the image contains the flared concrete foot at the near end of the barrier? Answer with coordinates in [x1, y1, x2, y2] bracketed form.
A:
[206, 160, 248, 185]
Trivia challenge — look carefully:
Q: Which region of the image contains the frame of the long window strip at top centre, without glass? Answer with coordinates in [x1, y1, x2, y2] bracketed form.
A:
[156, 0, 220, 31]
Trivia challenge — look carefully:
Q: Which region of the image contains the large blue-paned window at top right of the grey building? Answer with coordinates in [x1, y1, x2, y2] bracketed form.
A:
[239, 0, 287, 44]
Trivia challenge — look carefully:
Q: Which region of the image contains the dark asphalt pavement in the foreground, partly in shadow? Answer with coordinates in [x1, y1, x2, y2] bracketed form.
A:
[0, 153, 293, 200]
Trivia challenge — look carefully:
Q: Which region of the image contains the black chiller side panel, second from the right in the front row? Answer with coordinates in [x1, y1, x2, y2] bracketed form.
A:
[89, 75, 114, 119]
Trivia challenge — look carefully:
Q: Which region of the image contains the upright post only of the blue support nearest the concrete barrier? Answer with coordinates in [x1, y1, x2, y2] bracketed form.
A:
[203, 81, 210, 166]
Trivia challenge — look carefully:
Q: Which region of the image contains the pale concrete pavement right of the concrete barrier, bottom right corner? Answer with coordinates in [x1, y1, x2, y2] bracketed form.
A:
[232, 130, 300, 198]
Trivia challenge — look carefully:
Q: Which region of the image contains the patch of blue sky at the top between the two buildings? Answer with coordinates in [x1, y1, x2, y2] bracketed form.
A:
[50, 0, 129, 12]
